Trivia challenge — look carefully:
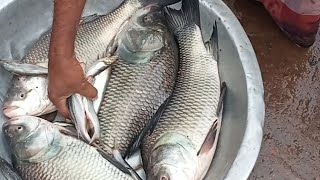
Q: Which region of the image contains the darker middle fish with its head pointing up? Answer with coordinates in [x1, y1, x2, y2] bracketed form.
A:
[98, 6, 178, 156]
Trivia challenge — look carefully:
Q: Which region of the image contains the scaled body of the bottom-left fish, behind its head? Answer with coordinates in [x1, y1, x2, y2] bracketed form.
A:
[15, 136, 133, 180]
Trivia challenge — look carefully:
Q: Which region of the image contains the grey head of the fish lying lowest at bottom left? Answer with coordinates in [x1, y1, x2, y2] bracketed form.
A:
[2, 116, 59, 162]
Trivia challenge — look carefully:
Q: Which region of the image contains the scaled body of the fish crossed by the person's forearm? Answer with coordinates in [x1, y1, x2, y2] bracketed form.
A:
[21, 0, 142, 67]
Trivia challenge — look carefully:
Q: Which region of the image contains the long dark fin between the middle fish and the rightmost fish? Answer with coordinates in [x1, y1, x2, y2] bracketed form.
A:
[125, 95, 172, 157]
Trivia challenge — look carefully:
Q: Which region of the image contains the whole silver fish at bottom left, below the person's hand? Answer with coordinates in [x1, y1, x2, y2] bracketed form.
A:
[3, 116, 137, 180]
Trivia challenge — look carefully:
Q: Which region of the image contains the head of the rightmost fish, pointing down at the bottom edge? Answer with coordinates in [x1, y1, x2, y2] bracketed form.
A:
[147, 133, 198, 180]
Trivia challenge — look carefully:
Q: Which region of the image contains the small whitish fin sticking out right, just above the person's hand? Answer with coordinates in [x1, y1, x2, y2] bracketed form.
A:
[86, 56, 119, 77]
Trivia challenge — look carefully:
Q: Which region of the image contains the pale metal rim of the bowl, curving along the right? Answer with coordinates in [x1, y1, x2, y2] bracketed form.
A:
[200, 0, 265, 180]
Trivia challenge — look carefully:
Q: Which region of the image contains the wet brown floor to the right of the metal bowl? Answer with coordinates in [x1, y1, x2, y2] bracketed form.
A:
[225, 0, 320, 180]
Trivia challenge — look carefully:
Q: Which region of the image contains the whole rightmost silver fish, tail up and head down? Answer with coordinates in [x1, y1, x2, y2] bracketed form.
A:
[142, 0, 225, 180]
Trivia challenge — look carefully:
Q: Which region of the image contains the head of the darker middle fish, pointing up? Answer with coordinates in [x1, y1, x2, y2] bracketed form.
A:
[117, 5, 168, 63]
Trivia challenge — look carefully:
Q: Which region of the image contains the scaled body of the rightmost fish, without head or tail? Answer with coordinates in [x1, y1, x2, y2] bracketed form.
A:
[142, 26, 220, 158]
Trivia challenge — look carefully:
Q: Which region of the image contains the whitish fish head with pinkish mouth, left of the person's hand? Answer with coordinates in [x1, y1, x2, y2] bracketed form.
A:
[3, 75, 55, 118]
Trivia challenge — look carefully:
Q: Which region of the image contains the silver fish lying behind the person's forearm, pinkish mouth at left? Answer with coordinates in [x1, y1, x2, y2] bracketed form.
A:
[0, 0, 178, 118]
